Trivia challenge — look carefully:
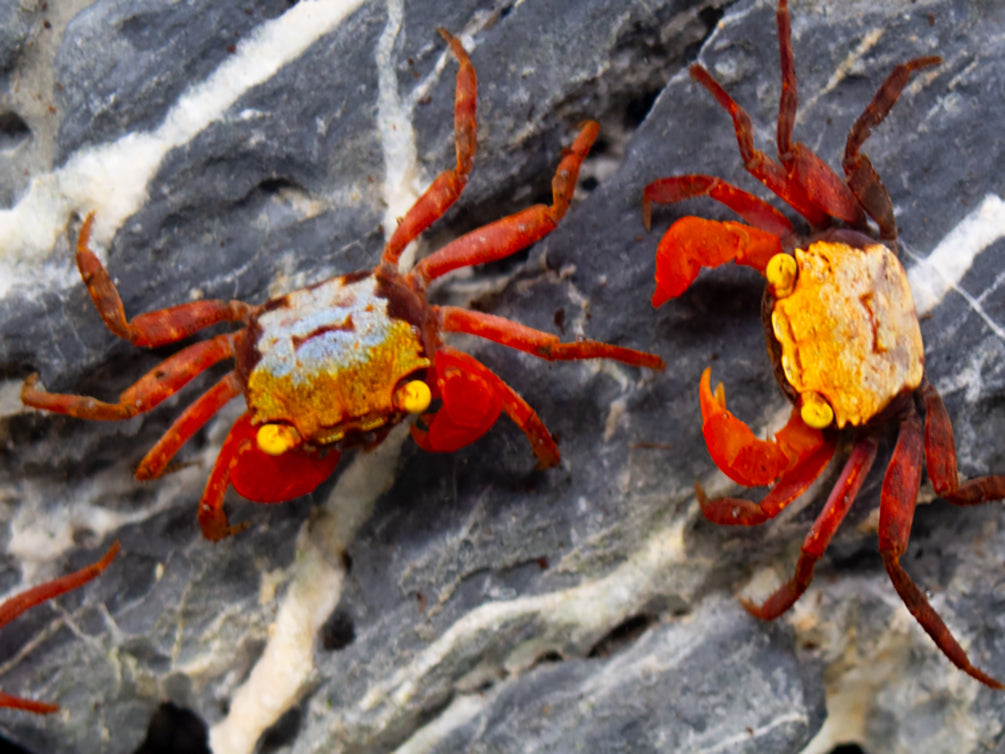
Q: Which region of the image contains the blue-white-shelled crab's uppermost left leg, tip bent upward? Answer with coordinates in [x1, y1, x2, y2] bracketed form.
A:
[76, 212, 252, 348]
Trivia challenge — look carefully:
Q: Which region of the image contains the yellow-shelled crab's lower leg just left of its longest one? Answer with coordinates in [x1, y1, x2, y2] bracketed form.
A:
[742, 437, 876, 620]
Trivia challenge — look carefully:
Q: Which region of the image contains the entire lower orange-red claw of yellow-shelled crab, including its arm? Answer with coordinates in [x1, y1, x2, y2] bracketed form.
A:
[698, 367, 824, 487]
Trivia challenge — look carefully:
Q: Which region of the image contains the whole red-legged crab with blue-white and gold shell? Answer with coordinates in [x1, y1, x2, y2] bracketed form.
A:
[21, 29, 663, 541]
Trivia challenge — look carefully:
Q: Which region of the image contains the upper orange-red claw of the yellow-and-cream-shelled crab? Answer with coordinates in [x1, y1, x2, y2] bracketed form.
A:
[652, 217, 782, 308]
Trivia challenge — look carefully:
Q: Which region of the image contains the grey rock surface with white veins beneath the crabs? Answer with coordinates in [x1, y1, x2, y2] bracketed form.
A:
[0, 0, 1005, 754]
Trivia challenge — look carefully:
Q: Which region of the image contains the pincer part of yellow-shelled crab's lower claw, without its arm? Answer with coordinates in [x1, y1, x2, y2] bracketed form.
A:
[698, 367, 799, 487]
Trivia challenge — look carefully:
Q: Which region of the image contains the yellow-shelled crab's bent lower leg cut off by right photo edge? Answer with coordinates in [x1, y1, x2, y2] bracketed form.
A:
[921, 380, 1005, 506]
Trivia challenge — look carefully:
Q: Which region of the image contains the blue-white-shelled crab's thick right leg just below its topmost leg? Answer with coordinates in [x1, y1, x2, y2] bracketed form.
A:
[412, 121, 600, 282]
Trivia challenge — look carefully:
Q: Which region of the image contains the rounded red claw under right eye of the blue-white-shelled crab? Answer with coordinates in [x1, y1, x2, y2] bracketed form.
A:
[412, 349, 503, 452]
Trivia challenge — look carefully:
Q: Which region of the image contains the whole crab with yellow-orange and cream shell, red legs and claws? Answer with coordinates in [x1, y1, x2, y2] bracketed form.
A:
[642, 0, 1005, 689]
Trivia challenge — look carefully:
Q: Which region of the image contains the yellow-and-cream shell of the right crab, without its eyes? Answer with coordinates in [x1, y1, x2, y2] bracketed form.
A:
[763, 230, 925, 428]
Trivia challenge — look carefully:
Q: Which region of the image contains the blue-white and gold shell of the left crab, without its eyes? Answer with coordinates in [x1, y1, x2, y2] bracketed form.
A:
[236, 270, 432, 445]
